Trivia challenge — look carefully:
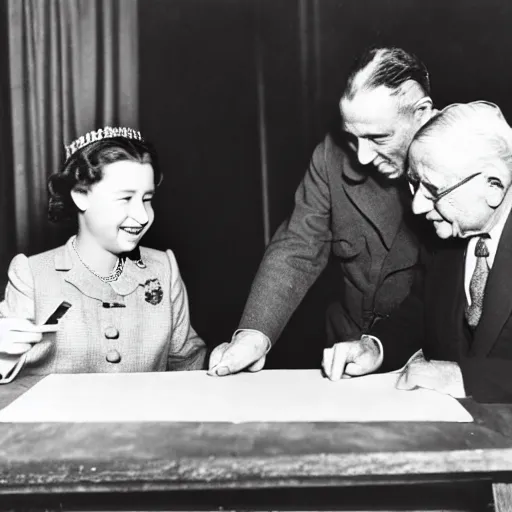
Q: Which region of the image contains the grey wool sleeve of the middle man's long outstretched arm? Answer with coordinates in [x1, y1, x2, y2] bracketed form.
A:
[239, 143, 332, 343]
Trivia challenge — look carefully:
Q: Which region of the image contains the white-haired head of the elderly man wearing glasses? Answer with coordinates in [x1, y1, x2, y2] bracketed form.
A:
[408, 101, 512, 238]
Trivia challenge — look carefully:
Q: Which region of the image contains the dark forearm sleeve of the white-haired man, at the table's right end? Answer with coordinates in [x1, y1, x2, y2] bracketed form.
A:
[459, 357, 512, 403]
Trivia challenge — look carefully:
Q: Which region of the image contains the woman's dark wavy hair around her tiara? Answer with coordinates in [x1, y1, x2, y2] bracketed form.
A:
[48, 137, 163, 222]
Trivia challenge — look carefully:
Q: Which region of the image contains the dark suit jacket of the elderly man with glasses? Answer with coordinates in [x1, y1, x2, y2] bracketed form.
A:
[372, 210, 512, 402]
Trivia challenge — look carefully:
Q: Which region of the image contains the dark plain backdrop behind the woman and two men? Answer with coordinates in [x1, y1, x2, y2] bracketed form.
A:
[0, 0, 512, 368]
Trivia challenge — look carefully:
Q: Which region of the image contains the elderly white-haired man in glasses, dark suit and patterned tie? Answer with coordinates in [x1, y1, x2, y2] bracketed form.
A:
[323, 101, 512, 402]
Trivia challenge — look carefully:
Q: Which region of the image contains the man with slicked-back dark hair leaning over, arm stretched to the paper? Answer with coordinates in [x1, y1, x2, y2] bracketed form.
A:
[209, 48, 433, 375]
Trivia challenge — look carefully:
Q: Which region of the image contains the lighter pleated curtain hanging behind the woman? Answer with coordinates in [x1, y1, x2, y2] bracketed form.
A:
[8, 0, 138, 253]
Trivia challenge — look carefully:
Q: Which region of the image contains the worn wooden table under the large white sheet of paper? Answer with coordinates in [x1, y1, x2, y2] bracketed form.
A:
[0, 378, 512, 512]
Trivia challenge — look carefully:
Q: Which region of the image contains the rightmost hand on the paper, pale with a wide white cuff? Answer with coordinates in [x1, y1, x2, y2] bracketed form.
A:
[396, 353, 466, 398]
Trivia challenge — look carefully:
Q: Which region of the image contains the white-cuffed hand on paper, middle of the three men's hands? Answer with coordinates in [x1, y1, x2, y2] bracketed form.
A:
[322, 335, 382, 380]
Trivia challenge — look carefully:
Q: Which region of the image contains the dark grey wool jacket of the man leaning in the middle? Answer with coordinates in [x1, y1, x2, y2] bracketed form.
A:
[239, 135, 428, 342]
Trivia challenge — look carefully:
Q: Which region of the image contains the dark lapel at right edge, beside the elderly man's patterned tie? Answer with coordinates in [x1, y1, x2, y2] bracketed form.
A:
[473, 214, 512, 356]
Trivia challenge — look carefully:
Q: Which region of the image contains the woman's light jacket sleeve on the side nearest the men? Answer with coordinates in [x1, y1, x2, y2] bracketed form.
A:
[167, 250, 207, 371]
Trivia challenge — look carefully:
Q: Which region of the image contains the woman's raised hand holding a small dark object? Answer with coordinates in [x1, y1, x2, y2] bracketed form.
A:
[0, 318, 47, 355]
